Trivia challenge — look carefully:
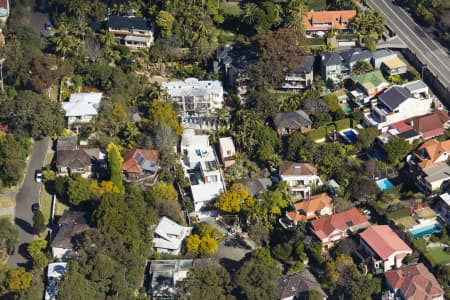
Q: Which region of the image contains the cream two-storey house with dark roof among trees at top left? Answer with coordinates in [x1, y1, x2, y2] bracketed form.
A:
[106, 16, 154, 49]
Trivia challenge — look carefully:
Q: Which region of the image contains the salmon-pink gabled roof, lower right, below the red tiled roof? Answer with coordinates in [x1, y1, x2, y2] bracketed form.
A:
[359, 225, 412, 260]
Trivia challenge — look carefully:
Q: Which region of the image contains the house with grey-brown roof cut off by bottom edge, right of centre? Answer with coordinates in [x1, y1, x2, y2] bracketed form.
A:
[275, 269, 328, 300]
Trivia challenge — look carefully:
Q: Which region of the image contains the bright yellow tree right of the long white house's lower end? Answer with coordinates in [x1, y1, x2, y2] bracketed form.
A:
[214, 183, 256, 213]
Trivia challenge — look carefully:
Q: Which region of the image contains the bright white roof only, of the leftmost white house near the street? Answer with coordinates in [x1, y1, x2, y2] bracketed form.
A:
[62, 93, 102, 117]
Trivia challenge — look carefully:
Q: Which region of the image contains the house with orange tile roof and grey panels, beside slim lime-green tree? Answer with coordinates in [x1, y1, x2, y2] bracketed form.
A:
[122, 149, 161, 186]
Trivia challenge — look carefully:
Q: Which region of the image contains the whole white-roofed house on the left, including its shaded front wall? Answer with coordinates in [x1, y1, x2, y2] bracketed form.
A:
[62, 93, 102, 128]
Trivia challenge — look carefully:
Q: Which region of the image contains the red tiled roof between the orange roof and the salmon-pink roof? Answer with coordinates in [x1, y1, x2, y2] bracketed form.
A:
[311, 208, 369, 239]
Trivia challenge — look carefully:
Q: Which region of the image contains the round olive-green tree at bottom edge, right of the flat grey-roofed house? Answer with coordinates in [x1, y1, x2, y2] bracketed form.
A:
[181, 264, 234, 300]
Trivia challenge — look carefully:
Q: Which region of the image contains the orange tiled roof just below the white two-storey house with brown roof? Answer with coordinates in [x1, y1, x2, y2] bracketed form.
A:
[286, 193, 333, 223]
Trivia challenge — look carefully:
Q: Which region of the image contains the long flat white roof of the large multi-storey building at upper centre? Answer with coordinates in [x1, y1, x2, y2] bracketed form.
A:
[162, 78, 223, 97]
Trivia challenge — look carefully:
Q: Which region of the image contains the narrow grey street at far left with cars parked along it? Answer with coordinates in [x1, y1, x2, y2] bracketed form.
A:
[8, 137, 49, 267]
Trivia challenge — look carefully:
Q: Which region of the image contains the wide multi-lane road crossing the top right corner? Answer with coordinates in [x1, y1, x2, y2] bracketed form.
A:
[370, 0, 450, 88]
